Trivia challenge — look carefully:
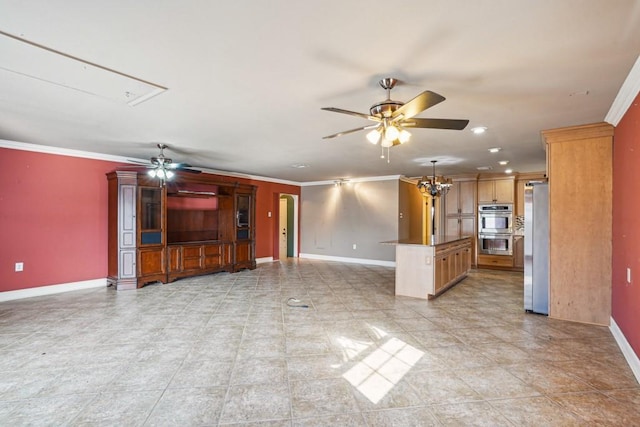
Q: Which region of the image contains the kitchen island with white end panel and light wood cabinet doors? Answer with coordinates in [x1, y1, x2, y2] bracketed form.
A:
[383, 236, 471, 299]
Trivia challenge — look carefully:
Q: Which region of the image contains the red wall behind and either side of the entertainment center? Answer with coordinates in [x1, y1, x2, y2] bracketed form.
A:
[0, 148, 300, 292]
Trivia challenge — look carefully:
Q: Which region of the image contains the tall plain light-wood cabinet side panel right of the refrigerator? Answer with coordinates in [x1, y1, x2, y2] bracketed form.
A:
[542, 123, 614, 326]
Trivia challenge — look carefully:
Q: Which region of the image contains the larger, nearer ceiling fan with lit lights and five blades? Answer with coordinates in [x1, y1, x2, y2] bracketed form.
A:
[322, 77, 469, 161]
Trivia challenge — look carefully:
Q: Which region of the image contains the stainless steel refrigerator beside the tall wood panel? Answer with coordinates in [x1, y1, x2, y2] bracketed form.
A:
[524, 182, 549, 314]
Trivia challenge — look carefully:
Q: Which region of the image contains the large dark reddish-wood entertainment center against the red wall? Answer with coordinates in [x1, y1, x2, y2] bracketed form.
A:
[107, 171, 256, 290]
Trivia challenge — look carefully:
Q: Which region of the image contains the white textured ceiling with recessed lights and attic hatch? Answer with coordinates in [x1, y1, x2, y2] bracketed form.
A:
[0, 0, 640, 183]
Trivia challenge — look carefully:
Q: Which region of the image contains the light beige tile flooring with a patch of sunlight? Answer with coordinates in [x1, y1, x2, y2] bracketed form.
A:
[0, 260, 640, 426]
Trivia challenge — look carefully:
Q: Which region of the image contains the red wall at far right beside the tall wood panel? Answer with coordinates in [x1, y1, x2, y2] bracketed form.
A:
[611, 95, 640, 356]
